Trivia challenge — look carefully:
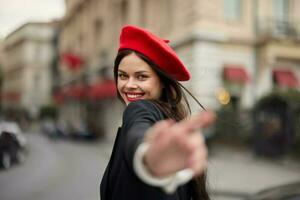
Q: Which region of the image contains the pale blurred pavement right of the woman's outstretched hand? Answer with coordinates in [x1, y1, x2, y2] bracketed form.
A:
[208, 146, 300, 200]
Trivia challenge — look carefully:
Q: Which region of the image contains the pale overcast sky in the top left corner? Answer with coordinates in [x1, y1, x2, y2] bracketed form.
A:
[0, 0, 65, 39]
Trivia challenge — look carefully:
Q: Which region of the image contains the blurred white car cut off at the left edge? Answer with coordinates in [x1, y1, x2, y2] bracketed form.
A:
[0, 122, 27, 169]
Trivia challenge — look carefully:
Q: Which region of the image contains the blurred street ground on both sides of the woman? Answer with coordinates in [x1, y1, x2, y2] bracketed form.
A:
[0, 127, 300, 200]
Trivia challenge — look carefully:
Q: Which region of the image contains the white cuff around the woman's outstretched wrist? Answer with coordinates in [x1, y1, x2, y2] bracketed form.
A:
[133, 143, 194, 194]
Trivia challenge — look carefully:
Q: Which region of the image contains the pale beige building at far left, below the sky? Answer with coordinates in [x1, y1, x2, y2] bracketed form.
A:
[2, 23, 57, 118]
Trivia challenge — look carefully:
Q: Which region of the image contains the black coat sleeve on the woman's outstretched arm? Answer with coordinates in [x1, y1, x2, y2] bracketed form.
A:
[122, 100, 164, 170]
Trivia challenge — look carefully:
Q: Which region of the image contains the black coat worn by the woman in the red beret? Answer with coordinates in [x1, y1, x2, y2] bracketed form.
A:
[100, 100, 192, 200]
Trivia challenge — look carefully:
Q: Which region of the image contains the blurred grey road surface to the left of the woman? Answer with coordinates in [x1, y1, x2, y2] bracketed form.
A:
[0, 128, 111, 200]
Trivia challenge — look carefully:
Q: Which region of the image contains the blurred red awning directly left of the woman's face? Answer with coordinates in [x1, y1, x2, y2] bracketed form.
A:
[87, 80, 117, 100]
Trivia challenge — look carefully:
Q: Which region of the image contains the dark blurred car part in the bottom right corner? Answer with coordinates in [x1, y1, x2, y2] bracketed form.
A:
[246, 181, 300, 200]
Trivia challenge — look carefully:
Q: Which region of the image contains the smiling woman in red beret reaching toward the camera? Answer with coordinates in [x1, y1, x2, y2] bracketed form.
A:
[100, 26, 214, 200]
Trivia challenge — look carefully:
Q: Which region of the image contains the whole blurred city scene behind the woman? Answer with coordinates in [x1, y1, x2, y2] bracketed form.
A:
[0, 0, 300, 200]
